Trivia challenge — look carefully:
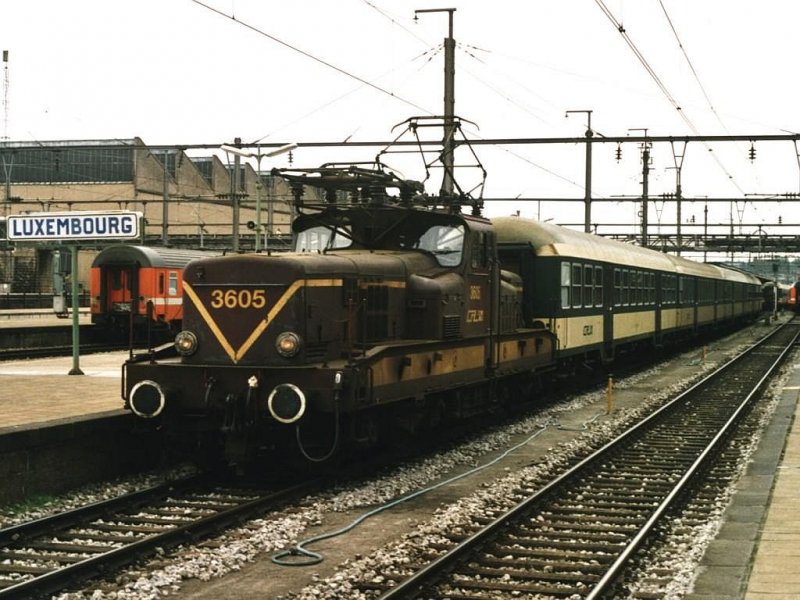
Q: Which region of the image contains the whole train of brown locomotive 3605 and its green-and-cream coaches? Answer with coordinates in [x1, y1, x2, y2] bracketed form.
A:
[123, 167, 762, 463]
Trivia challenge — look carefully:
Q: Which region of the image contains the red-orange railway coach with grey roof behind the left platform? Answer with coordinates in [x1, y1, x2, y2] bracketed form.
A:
[89, 244, 218, 333]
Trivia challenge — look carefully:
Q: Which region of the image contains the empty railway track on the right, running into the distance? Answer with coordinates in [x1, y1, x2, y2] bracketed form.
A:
[376, 321, 800, 600]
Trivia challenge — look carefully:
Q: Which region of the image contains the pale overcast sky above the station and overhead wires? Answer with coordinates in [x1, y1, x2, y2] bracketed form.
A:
[0, 0, 800, 232]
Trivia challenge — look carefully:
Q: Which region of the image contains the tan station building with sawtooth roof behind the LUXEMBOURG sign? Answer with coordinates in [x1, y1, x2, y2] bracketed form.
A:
[0, 138, 300, 295]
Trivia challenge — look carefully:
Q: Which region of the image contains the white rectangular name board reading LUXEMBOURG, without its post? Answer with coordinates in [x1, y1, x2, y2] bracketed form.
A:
[7, 210, 142, 241]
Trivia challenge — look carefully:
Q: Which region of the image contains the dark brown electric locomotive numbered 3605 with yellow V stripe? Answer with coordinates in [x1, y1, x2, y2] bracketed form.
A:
[123, 167, 557, 462]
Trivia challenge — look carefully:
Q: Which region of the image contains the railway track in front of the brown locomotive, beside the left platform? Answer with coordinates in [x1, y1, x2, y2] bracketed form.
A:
[0, 477, 319, 598]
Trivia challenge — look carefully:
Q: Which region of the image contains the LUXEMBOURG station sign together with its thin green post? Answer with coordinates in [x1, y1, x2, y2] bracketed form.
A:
[7, 210, 142, 375]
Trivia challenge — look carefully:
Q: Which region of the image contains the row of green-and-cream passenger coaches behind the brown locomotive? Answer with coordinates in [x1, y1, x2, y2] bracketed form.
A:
[493, 217, 762, 361]
